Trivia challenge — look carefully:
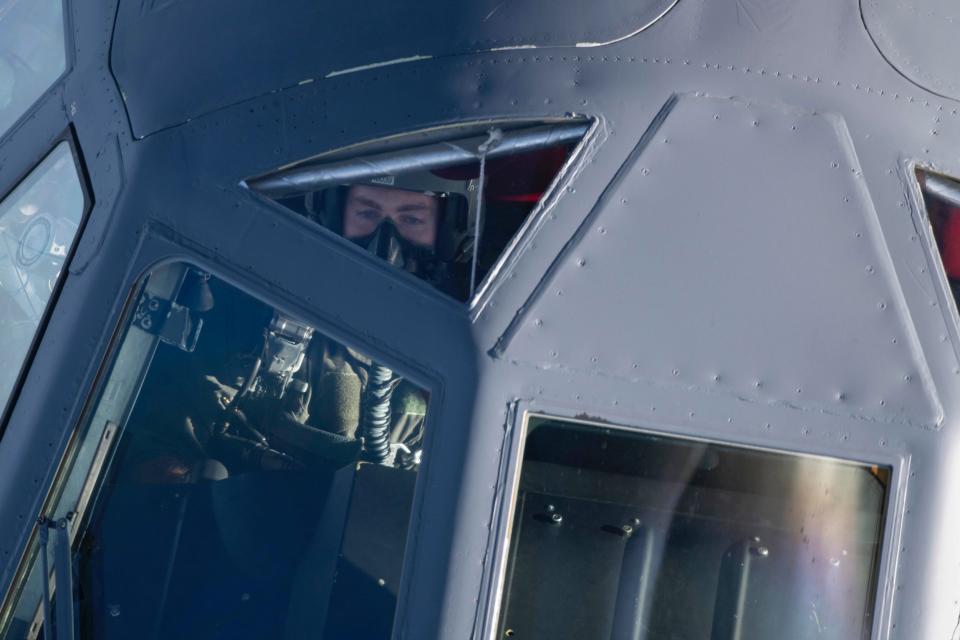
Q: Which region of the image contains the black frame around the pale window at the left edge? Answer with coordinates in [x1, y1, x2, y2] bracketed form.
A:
[0, 124, 95, 441]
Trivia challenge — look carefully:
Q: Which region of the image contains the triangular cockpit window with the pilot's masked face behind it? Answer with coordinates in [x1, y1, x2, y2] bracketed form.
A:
[247, 119, 589, 300]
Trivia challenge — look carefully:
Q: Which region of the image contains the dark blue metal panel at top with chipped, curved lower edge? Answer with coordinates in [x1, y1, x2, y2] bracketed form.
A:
[112, 0, 677, 136]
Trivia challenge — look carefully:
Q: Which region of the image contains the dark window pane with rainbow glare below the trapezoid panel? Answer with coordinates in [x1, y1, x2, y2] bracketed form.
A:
[498, 417, 889, 640]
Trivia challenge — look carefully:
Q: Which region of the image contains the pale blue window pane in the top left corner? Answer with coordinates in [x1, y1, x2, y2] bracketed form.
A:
[0, 0, 67, 137]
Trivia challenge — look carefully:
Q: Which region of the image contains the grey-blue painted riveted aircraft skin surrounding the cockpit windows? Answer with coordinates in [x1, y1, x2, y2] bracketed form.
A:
[0, 0, 960, 639]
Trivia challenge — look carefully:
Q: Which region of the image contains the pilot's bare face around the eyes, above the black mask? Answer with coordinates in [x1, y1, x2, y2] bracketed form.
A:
[343, 185, 439, 247]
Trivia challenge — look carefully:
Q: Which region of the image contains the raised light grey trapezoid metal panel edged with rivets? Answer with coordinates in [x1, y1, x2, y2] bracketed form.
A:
[498, 95, 942, 428]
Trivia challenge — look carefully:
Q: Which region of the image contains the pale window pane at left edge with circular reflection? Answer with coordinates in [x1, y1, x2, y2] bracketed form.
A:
[0, 141, 84, 416]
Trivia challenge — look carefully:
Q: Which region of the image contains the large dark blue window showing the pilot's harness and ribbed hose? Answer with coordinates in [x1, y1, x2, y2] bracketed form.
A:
[2, 265, 429, 640]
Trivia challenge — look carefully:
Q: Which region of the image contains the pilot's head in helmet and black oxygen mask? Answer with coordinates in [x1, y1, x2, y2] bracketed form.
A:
[312, 172, 477, 295]
